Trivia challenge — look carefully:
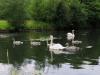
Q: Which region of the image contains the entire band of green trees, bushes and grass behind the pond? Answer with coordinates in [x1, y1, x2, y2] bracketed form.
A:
[0, 0, 100, 30]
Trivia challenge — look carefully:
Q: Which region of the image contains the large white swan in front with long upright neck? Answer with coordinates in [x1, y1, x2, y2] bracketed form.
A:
[48, 35, 65, 50]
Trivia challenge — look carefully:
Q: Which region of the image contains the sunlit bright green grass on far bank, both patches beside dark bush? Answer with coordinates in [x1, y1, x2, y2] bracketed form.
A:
[0, 20, 52, 31]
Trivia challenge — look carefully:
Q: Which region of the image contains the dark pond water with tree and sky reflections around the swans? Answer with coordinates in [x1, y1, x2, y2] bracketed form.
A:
[0, 30, 100, 75]
